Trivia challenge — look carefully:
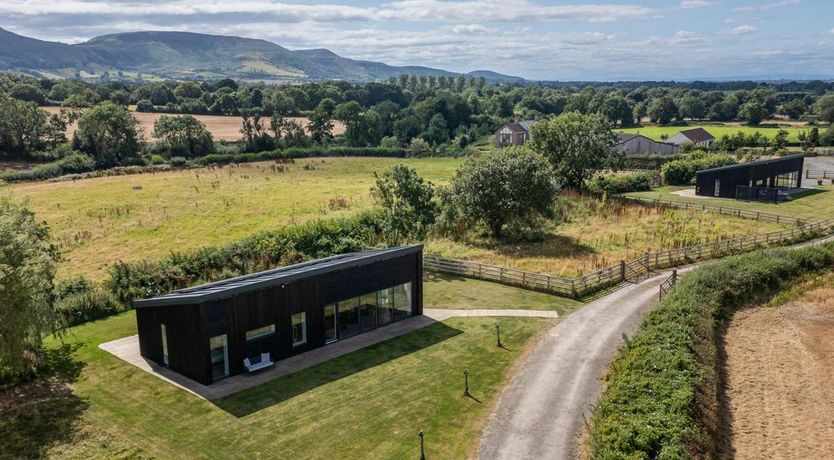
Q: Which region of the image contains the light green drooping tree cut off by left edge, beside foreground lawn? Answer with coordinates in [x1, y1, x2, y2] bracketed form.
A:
[0, 198, 58, 380]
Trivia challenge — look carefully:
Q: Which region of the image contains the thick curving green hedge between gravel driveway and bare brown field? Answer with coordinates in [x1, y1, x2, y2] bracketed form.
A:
[590, 243, 834, 460]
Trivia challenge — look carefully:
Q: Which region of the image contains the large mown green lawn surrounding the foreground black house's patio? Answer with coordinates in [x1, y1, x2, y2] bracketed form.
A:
[0, 276, 555, 459]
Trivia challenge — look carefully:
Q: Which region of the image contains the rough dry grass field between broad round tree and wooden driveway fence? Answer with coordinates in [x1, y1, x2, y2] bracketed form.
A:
[427, 196, 788, 276]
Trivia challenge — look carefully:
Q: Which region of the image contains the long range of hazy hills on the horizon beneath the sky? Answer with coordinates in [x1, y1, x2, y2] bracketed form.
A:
[0, 29, 523, 82]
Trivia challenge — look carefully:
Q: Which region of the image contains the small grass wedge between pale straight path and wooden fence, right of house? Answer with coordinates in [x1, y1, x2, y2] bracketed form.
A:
[423, 273, 582, 315]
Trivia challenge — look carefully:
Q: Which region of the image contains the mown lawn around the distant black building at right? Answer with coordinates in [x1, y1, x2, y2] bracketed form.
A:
[626, 185, 834, 226]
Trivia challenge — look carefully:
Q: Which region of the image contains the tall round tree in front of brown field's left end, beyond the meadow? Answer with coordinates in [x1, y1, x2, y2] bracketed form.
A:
[73, 102, 140, 166]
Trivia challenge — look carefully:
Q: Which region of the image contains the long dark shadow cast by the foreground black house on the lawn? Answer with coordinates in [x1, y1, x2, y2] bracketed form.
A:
[212, 322, 463, 417]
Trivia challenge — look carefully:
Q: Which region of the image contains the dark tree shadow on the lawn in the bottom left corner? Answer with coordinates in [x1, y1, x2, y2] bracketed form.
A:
[0, 344, 89, 458]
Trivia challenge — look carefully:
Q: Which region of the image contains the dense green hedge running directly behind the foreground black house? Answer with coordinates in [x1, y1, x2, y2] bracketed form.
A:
[105, 212, 382, 304]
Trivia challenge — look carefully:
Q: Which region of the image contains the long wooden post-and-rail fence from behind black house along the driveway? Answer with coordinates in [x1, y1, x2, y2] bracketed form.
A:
[423, 218, 834, 299]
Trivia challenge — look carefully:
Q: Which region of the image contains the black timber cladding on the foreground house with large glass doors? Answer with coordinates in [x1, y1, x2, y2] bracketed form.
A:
[136, 248, 423, 384]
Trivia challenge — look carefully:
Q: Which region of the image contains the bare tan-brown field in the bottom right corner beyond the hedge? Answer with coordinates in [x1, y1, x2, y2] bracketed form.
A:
[724, 274, 834, 460]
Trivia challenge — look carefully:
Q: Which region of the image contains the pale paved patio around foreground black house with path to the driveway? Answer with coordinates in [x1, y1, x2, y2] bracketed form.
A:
[99, 309, 559, 400]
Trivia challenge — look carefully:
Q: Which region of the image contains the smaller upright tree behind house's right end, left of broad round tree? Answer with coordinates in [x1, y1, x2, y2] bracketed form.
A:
[373, 165, 438, 244]
